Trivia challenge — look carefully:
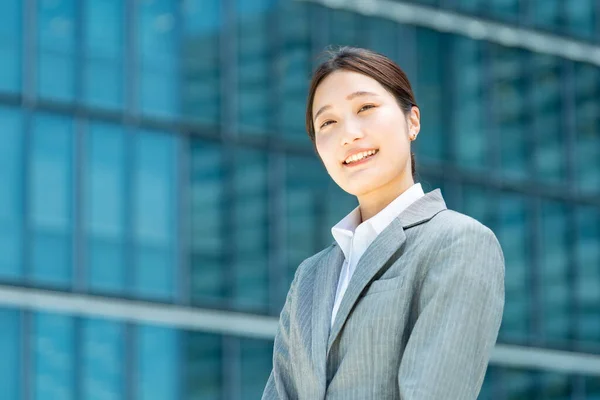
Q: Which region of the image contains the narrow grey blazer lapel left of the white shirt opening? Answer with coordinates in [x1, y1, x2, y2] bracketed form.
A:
[311, 243, 344, 389]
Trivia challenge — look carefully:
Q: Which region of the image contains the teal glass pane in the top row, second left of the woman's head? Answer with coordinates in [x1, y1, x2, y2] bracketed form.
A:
[236, 0, 273, 135]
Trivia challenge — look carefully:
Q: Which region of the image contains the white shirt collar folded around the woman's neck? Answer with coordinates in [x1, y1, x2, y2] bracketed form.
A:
[331, 183, 425, 257]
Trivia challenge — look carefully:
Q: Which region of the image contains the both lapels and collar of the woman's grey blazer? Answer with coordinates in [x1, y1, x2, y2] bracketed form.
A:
[312, 189, 447, 370]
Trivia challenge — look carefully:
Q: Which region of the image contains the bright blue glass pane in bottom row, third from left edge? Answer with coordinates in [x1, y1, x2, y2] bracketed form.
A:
[82, 319, 125, 400]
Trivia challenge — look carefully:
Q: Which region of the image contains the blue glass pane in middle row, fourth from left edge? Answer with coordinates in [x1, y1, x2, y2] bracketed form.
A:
[133, 132, 178, 299]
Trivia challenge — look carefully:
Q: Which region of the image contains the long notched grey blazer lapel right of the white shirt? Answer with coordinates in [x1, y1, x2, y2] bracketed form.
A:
[326, 189, 446, 355]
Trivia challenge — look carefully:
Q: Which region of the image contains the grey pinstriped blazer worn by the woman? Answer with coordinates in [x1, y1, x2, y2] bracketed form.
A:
[262, 189, 504, 400]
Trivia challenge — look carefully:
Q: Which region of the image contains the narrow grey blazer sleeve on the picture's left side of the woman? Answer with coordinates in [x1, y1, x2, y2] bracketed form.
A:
[262, 267, 300, 400]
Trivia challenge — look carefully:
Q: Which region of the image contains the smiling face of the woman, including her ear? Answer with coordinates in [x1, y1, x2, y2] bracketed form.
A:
[312, 70, 420, 201]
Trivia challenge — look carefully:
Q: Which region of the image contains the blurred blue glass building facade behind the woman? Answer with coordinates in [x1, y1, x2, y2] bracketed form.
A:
[0, 0, 600, 400]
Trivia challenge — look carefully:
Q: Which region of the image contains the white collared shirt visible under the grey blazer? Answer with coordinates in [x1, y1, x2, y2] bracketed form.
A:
[331, 183, 425, 326]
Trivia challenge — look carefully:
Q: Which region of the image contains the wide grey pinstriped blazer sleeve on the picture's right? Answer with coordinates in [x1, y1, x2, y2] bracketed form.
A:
[398, 220, 504, 400]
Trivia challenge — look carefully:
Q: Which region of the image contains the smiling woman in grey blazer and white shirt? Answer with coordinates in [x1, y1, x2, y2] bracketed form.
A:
[263, 47, 504, 400]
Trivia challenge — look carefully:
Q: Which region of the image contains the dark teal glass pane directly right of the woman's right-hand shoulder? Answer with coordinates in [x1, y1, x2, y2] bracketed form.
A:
[493, 194, 532, 344]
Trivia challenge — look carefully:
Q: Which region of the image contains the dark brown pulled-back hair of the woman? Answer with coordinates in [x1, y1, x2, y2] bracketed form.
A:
[306, 46, 418, 177]
